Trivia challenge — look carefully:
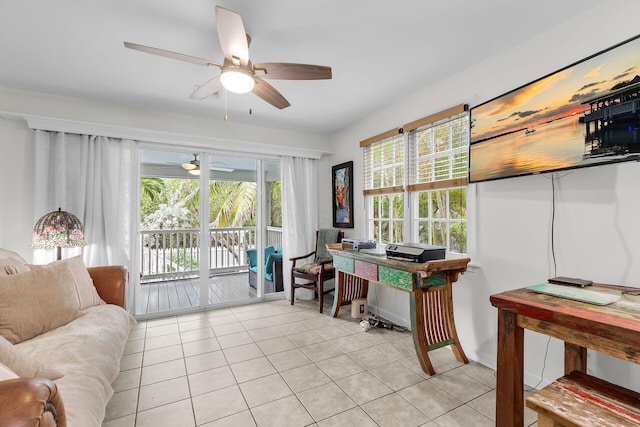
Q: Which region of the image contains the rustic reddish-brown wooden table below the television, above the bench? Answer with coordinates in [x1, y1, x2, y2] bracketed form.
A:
[490, 284, 640, 427]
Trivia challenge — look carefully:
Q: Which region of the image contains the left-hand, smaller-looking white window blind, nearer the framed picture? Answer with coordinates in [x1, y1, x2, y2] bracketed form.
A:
[360, 129, 405, 196]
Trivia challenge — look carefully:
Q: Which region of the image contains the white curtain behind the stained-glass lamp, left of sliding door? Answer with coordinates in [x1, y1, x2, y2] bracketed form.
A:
[33, 130, 137, 270]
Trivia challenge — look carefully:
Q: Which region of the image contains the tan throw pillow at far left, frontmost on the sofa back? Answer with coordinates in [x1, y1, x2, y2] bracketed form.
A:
[0, 264, 80, 344]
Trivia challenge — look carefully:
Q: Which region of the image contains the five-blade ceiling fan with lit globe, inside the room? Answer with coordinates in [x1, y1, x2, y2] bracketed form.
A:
[124, 6, 331, 109]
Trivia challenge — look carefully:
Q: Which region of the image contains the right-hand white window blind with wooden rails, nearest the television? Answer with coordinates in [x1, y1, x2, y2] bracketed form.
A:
[404, 105, 469, 192]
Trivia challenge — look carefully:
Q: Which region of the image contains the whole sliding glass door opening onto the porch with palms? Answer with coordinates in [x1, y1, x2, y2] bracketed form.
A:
[136, 148, 282, 317]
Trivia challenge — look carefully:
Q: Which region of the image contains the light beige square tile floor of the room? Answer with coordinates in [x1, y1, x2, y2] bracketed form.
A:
[102, 300, 536, 427]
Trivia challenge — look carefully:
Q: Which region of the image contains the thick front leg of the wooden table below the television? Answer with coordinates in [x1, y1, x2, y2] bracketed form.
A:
[496, 309, 524, 427]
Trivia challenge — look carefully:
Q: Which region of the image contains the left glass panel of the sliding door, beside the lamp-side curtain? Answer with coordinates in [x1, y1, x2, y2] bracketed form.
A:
[136, 150, 202, 315]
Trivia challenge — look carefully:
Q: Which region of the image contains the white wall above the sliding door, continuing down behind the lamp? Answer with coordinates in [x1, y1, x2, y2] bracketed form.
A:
[0, 86, 329, 259]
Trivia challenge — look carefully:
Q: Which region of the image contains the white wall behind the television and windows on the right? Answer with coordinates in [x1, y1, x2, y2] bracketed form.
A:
[318, 0, 640, 390]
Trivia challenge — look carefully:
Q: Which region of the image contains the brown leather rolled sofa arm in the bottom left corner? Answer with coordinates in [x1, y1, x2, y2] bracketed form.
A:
[0, 378, 67, 427]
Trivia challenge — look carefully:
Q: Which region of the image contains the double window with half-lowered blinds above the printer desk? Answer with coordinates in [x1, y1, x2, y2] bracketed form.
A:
[360, 105, 469, 253]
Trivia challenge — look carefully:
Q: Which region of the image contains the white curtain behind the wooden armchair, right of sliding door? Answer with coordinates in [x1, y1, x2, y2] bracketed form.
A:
[282, 156, 318, 299]
